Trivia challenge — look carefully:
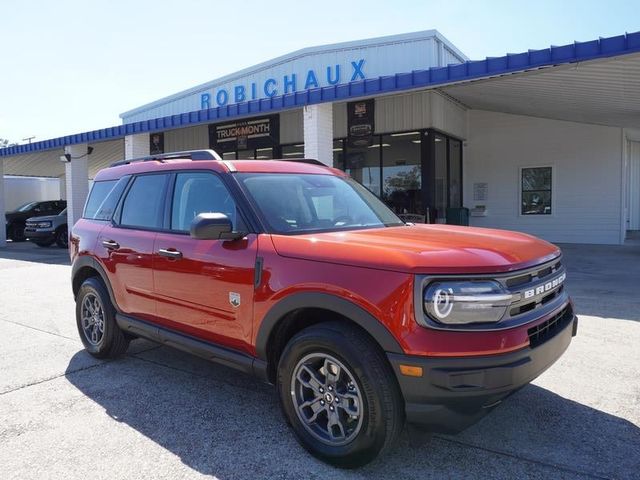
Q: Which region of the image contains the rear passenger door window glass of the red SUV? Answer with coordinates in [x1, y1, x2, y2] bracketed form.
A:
[120, 174, 168, 229]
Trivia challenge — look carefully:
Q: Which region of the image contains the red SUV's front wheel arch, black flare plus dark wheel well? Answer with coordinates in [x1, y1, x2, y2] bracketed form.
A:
[256, 292, 403, 381]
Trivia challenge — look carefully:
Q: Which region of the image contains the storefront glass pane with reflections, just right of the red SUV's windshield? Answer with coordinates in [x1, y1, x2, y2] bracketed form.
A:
[382, 132, 423, 214]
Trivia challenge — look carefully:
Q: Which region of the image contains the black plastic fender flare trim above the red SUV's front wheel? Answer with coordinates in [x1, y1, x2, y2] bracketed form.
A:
[256, 292, 404, 361]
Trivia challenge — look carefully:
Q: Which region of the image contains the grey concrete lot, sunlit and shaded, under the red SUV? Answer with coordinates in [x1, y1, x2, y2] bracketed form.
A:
[0, 244, 640, 480]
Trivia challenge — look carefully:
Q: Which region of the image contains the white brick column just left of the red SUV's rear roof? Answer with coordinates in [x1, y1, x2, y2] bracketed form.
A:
[65, 143, 89, 231]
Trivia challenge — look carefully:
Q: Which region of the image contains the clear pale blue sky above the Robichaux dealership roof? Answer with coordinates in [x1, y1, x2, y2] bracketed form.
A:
[0, 0, 640, 143]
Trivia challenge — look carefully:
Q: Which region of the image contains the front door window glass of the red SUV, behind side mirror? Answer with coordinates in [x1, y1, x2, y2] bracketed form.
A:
[171, 172, 242, 232]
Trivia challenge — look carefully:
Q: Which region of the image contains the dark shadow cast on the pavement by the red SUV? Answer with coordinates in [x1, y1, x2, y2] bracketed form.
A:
[66, 342, 640, 480]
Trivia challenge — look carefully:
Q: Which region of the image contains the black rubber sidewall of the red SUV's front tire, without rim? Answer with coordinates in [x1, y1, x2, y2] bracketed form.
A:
[277, 329, 388, 467]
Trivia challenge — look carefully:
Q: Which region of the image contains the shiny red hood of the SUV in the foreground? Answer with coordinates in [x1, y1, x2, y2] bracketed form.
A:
[271, 225, 560, 274]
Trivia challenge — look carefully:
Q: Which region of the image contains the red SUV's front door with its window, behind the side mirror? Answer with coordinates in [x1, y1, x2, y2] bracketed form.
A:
[153, 171, 258, 352]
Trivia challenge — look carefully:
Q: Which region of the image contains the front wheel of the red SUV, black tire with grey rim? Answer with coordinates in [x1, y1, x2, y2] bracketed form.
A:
[277, 322, 404, 468]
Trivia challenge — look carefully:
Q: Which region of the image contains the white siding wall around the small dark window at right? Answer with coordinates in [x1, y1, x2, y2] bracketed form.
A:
[463, 110, 623, 244]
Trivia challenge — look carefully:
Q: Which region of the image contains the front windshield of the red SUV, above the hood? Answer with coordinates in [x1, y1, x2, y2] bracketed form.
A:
[238, 173, 404, 234]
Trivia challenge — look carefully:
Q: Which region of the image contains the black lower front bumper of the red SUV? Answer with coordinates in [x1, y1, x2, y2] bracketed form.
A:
[387, 306, 578, 433]
